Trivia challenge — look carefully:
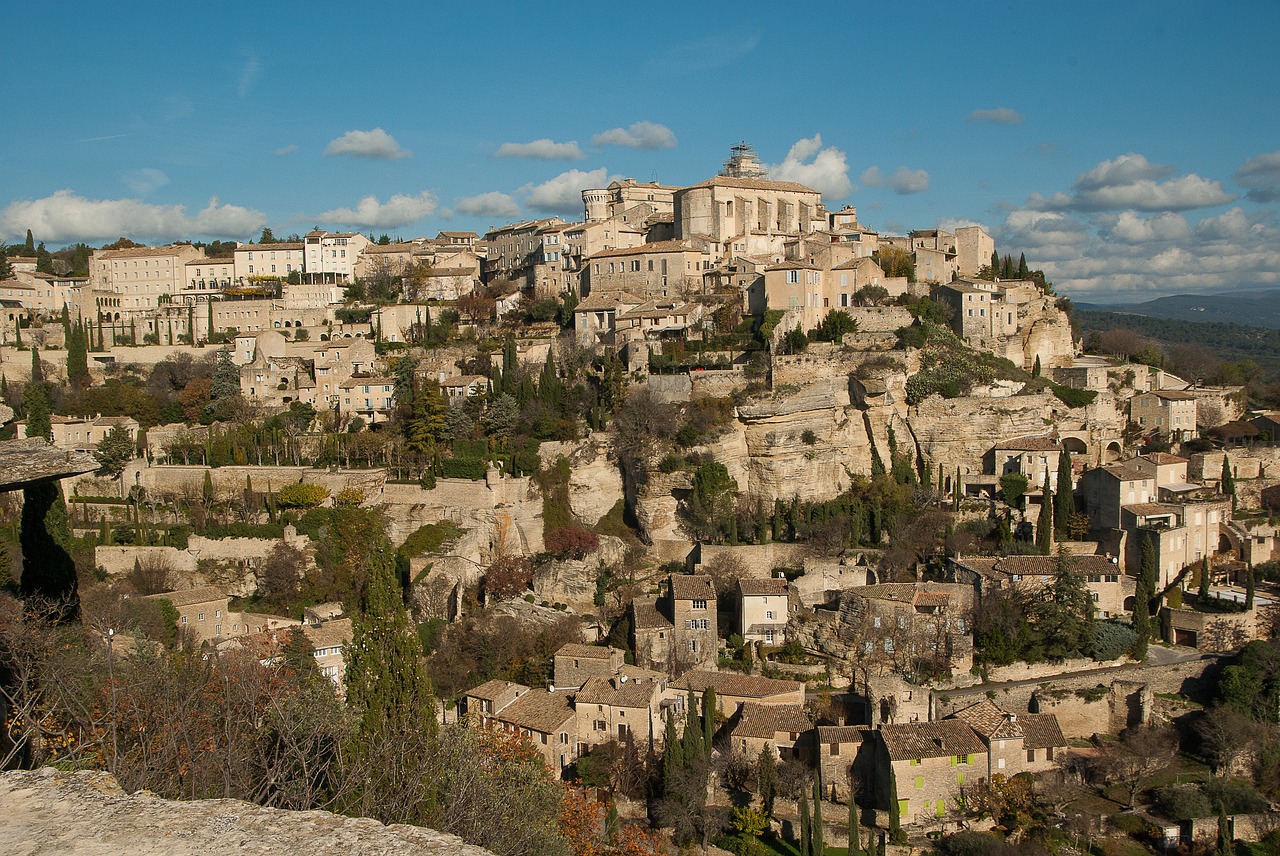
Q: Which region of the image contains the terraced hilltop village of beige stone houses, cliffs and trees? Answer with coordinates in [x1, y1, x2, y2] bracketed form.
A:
[0, 145, 1280, 855]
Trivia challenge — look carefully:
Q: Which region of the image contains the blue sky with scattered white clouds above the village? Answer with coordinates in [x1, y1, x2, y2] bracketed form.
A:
[0, 0, 1280, 302]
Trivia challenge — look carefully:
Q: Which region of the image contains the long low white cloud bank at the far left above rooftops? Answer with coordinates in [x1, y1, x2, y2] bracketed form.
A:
[0, 189, 266, 243]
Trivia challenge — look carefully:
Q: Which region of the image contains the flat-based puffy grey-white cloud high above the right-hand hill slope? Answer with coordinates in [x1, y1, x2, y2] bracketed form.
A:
[1027, 152, 1235, 211]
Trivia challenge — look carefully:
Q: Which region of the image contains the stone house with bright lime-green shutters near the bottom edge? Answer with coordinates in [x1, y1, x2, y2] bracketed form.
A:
[869, 719, 988, 827]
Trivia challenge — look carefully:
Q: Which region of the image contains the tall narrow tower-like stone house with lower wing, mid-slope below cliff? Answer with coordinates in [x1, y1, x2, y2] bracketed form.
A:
[631, 573, 719, 674]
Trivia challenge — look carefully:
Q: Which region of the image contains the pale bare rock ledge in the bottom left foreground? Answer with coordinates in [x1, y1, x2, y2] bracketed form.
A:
[0, 768, 493, 856]
